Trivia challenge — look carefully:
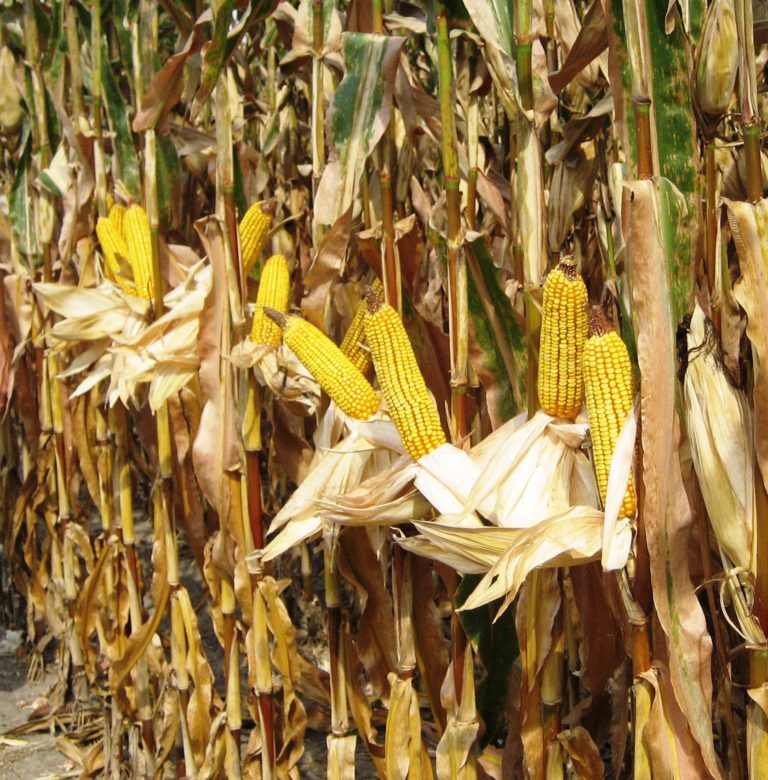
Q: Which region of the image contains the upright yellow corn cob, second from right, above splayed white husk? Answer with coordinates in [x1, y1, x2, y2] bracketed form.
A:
[538, 257, 589, 419]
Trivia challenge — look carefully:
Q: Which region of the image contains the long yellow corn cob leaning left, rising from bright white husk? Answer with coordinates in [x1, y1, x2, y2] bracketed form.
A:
[365, 287, 446, 460]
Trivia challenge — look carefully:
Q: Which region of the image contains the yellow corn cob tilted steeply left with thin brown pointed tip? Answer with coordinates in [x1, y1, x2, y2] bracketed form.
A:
[264, 307, 379, 420]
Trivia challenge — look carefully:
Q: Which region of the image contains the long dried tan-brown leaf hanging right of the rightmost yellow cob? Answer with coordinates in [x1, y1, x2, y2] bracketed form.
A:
[622, 181, 722, 778]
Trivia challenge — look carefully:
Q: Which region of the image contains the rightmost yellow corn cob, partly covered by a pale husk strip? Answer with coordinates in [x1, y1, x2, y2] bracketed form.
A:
[584, 306, 637, 517]
